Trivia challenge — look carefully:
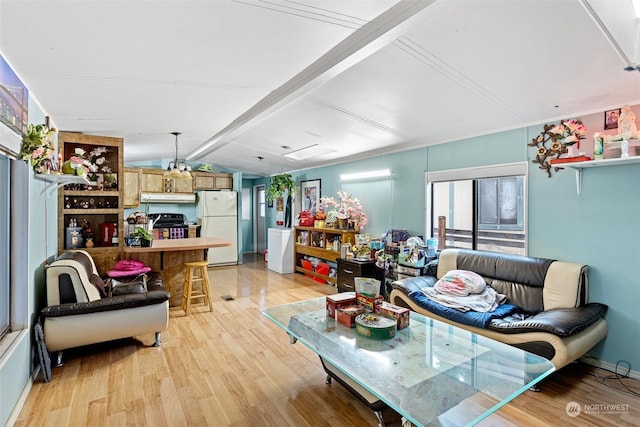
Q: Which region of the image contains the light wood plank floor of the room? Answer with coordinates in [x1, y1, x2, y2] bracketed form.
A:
[15, 256, 640, 427]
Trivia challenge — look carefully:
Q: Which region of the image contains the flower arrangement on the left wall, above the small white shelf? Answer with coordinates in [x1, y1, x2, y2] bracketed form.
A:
[19, 124, 57, 173]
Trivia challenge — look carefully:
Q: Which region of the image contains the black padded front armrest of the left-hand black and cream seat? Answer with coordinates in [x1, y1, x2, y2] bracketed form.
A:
[40, 290, 169, 317]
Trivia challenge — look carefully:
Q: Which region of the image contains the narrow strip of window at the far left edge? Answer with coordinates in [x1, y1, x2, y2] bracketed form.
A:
[0, 154, 11, 338]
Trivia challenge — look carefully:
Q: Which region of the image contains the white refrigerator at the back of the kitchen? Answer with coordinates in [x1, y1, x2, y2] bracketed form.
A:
[196, 191, 238, 265]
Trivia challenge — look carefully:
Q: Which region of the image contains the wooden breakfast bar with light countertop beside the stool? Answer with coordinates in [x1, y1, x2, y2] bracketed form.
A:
[124, 237, 231, 307]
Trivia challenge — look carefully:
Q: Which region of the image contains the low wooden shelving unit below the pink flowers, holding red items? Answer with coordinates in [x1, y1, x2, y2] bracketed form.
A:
[293, 227, 356, 283]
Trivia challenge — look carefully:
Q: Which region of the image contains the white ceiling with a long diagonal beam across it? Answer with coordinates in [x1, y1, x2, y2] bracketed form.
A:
[0, 0, 640, 176]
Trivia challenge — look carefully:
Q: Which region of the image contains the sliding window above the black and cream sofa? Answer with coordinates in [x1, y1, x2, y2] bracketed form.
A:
[426, 163, 527, 255]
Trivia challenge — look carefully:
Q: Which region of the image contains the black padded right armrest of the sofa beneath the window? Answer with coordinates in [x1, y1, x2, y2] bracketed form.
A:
[488, 303, 608, 337]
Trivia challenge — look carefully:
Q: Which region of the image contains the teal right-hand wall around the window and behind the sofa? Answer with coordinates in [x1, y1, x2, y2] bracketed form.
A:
[270, 114, 640, 371]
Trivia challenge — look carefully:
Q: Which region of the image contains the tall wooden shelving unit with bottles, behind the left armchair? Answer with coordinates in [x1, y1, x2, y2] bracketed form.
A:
[57, 132, 125, 275]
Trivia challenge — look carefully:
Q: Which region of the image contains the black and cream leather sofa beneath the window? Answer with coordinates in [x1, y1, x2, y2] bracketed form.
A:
[390, 249, 607, 369]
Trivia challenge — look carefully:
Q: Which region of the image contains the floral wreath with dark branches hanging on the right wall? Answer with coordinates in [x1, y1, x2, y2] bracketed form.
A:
[527, 120, 587, 178]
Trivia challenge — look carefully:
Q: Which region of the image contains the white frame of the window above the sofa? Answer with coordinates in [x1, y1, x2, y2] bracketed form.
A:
[424, 162, 529, 254]
